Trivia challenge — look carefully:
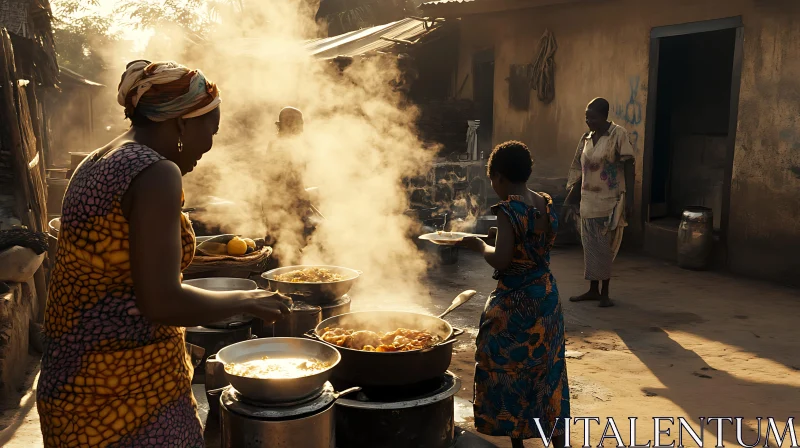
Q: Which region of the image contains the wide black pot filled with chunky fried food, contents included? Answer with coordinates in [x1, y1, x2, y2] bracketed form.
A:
[308, 311, 463, 387]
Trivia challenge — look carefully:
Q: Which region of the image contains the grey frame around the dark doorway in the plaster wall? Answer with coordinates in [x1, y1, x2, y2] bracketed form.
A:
[641, 16, 744, 256]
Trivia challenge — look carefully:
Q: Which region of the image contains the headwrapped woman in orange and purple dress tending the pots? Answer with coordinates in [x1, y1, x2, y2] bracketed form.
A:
[37, 61, 288, 448]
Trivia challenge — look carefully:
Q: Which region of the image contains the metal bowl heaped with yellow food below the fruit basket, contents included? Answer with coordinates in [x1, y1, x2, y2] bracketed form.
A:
[261, 265, 361, 305]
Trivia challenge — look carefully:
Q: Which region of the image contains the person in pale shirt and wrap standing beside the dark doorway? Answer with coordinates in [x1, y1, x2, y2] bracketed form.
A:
[567, 98, 635, 307]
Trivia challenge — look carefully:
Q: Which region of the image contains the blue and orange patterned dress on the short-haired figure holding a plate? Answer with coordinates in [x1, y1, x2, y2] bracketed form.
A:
[473, 193, 570, 439]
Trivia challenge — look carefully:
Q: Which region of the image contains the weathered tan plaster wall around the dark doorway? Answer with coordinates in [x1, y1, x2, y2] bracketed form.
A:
[456, 0, 800, 283]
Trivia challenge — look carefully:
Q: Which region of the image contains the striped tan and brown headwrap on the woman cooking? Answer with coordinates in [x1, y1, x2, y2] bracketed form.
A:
[117, 60, 222, 122]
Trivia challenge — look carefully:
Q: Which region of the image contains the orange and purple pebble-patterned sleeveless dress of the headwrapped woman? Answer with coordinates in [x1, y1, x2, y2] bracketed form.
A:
[37, 143, 204, 448]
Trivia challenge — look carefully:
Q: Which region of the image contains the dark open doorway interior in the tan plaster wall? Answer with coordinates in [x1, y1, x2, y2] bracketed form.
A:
[645, 19, 742, 242]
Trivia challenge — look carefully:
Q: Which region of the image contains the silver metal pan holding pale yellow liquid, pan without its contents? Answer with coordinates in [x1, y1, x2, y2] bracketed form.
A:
[217, 338, 342, 403]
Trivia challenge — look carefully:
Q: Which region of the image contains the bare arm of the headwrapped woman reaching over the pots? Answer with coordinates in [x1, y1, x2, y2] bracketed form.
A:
[123, 161, 288, 327]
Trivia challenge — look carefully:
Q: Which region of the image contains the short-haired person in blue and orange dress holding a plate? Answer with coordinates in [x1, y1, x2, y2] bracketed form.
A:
[456, 141, 570, 448]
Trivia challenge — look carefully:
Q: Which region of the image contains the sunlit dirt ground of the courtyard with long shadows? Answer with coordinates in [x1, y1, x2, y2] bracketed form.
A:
[0, 249, 800, 448]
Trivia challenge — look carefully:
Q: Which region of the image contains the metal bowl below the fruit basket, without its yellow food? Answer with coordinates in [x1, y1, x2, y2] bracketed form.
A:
[261, 265, 361, 305]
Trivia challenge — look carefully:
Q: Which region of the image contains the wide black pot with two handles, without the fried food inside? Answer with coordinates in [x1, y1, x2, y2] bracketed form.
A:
[309, 311, 463, 387]
